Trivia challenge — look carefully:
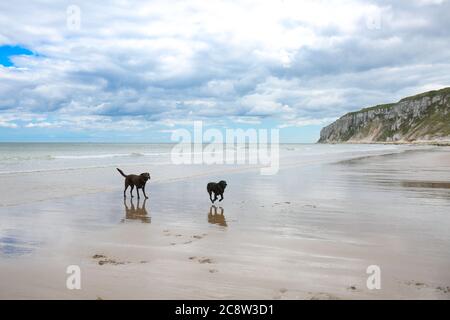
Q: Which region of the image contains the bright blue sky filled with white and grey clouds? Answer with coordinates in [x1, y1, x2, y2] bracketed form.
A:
[0, 0, 450, 142]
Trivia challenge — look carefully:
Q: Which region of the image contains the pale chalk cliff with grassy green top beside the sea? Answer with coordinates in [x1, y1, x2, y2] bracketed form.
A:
[319, 88, 450, 143]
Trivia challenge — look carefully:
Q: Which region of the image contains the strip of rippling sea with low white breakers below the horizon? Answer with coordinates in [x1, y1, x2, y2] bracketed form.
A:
[0, 143, 404, 176]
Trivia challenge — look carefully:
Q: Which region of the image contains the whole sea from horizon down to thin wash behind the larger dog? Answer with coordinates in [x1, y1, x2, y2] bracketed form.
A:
[0, 143, 409, 207]
